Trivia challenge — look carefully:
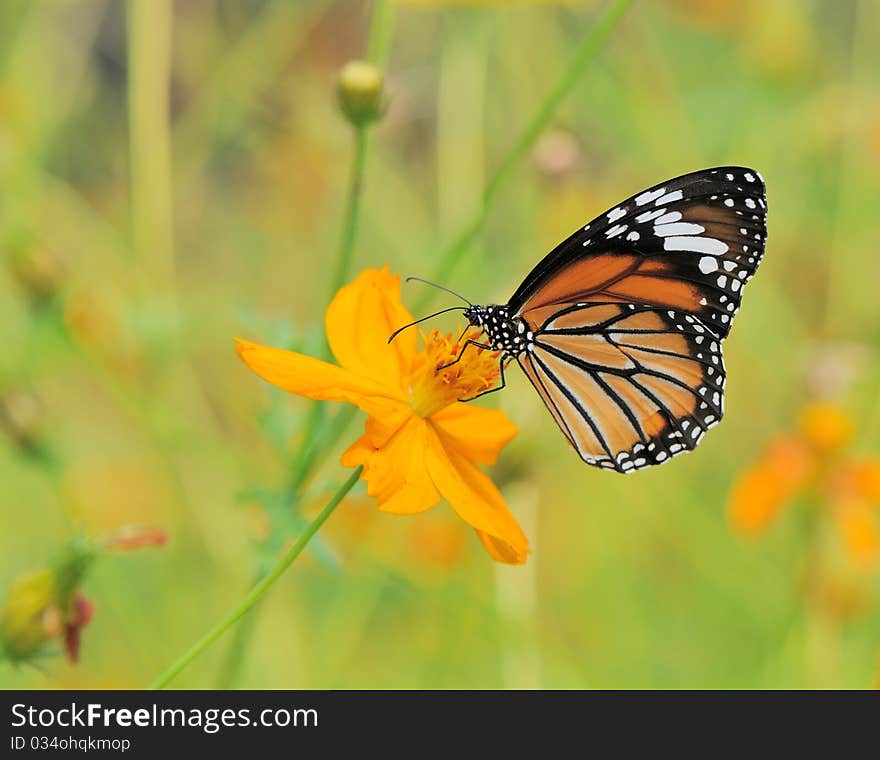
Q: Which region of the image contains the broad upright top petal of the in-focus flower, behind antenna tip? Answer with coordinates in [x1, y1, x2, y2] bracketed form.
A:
[326, 267, 417, 395]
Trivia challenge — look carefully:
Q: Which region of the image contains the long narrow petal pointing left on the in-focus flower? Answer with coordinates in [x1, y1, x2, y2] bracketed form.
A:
[236, 339, 411, 427]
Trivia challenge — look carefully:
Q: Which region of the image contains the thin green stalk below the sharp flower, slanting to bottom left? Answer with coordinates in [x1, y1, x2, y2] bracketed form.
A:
[150, 466, 363, 689]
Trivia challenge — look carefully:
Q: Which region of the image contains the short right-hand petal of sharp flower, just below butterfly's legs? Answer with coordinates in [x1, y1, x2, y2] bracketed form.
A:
[431, 403, 517, 465]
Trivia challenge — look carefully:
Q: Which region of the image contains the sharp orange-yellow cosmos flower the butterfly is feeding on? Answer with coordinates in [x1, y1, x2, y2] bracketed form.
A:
[237, 267, 528, 564]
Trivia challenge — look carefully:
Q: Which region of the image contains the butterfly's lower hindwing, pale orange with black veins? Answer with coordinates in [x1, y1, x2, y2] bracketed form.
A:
[517, 303, 725, 472]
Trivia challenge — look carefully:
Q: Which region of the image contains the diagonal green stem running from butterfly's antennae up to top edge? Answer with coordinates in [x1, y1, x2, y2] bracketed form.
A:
[416, 0, 632, 311]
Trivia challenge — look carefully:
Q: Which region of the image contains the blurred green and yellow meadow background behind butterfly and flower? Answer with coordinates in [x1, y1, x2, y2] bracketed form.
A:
[0, 0, 880, 688]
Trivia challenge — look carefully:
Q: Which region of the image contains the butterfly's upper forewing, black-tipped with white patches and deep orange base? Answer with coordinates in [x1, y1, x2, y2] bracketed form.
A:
[508, 166, 767, 338]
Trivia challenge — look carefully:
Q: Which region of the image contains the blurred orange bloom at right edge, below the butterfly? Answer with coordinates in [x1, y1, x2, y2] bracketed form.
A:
[728, 402, 880, 568]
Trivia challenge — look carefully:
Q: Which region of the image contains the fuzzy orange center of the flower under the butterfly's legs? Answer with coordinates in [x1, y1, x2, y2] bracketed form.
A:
[409, 330, 500, 417]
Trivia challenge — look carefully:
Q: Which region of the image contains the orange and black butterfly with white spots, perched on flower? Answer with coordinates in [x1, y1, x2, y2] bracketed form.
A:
[392, 166, 767, 473]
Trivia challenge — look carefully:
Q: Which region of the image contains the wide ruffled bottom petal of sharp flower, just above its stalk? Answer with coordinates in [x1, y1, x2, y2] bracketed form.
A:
[342, 417, 440, 514]
